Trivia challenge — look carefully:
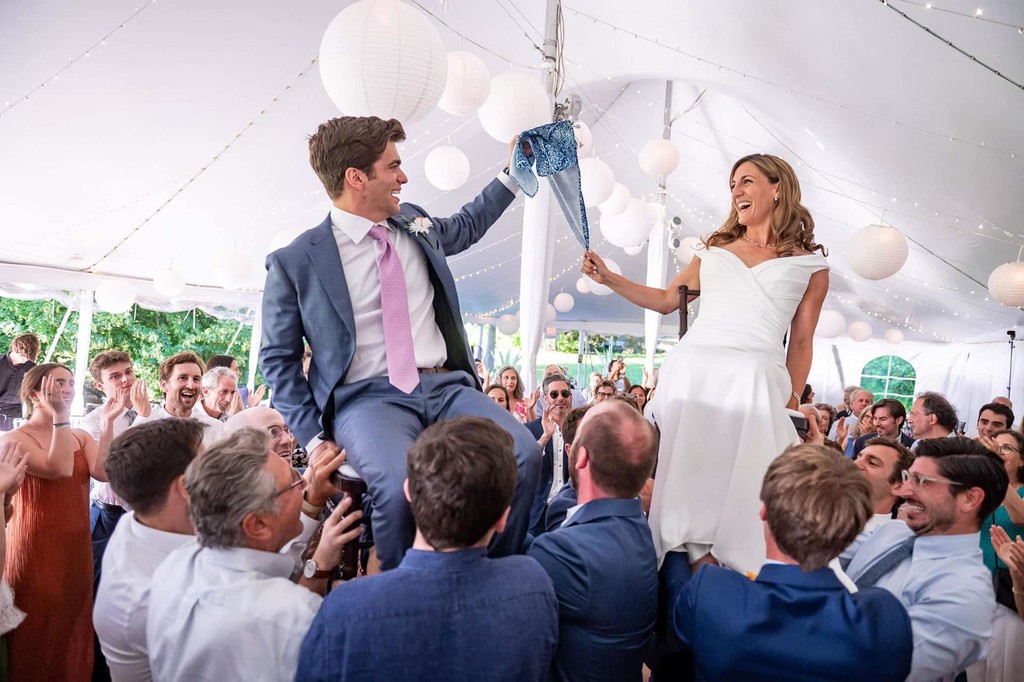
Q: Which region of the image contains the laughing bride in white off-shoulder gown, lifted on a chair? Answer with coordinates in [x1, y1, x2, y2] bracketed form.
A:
[582, 154, 828, 572]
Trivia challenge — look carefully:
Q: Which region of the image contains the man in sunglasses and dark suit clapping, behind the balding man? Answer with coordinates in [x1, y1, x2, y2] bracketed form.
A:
[526, 374, 572, 536]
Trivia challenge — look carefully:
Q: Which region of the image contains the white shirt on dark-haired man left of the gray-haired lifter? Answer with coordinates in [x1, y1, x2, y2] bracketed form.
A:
[92, 512, 196, 682]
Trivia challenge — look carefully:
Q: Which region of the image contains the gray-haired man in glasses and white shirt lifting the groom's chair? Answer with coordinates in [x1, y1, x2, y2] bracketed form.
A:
[146, 428, 361, 680]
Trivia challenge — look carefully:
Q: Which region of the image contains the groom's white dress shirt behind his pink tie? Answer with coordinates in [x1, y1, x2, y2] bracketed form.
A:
[331, 206, 447, 384]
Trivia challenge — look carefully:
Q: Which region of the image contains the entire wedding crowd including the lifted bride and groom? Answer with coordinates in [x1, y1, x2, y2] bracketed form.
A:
[0, 112, 1024, 682]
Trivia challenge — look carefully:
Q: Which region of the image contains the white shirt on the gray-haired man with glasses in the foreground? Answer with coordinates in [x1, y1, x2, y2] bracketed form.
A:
[146, 544, 322, 682]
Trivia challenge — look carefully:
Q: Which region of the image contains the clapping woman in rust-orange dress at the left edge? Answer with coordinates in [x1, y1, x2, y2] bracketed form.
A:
[0, 363, 116, 682]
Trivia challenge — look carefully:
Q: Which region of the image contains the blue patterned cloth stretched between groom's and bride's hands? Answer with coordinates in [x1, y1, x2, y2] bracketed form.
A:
[509, 121, 590, 249]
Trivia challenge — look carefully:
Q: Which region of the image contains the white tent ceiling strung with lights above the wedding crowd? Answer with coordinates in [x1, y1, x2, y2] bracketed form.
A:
[0, 0, 1024, 341]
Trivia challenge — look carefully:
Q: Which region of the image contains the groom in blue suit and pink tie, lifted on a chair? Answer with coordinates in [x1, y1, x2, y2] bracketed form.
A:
[260, 117, 541, 568]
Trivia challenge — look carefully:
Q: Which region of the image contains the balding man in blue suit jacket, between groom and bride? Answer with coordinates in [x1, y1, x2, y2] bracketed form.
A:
[529, 400, 657, 682]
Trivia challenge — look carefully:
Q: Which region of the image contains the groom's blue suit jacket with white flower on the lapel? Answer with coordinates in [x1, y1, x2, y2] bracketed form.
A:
[259, 179, 515, 443]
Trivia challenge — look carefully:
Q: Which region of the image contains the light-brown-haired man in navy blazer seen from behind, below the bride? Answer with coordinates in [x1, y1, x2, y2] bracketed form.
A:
[670, 444, 913, 682]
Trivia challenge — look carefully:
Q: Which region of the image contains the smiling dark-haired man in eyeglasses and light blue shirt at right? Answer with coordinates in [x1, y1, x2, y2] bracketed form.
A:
[841, 438, 1009, 681]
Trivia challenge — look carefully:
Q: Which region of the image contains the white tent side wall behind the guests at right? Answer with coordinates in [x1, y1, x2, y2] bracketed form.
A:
[808, 338, 1024, 434]
